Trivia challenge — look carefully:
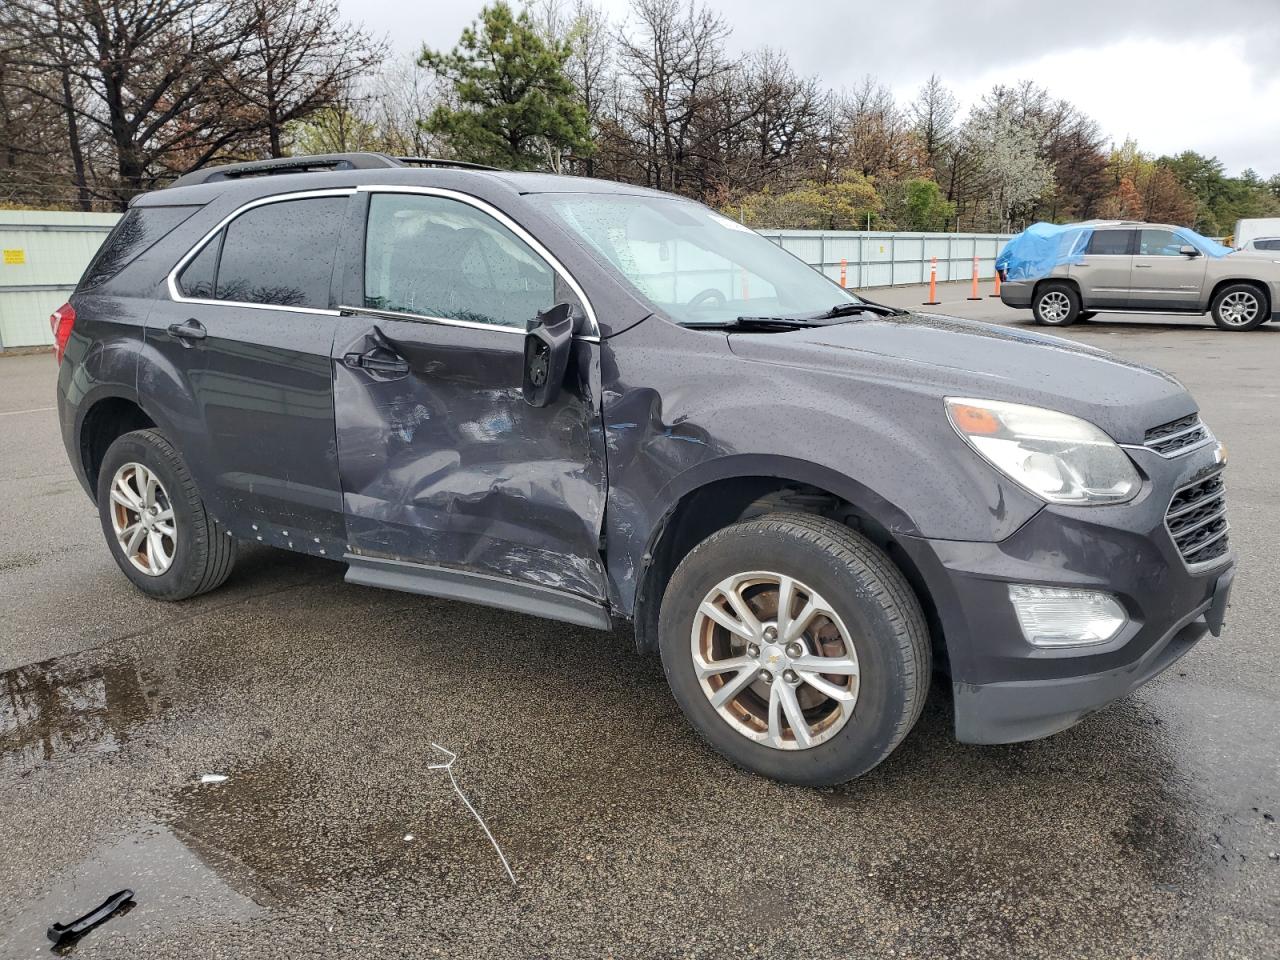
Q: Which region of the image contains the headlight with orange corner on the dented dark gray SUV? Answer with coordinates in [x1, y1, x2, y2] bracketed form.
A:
[946, 397, 1140, 506]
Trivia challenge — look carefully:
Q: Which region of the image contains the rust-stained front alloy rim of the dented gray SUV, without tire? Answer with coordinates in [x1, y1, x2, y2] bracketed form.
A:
[691, 571, 859, 750]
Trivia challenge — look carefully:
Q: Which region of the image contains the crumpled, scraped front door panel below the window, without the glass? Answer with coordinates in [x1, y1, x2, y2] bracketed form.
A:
[334, 315, 605, 599]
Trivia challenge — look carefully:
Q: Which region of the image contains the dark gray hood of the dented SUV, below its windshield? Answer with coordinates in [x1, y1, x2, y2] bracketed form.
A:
[728, 314, 1197, 443]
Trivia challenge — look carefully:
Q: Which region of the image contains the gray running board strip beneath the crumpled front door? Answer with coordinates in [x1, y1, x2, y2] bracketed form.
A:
[343, 553, 613, 630]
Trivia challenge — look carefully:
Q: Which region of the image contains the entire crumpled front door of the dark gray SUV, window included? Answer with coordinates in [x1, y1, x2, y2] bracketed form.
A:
[334, 192, 605, 599]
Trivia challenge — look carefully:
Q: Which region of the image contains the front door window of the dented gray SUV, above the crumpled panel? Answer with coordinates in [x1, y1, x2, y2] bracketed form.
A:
[365, 193, 563, 330]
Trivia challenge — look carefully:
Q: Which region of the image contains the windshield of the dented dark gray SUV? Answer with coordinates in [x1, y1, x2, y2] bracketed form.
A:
[529, 193, 861, 325]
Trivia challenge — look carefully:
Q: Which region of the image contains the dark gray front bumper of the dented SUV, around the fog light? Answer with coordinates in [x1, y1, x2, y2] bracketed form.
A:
[904, 445, 1234, 744]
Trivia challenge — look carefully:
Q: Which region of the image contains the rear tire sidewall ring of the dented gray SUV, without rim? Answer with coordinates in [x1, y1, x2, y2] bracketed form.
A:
[97, 431, 207, 599]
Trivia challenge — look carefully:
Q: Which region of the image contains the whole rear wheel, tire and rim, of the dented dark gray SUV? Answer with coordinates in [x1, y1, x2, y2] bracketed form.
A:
[97, 430, 236, 600]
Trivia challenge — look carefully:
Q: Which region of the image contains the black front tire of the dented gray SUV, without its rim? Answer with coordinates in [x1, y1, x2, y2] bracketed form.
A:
[659, 530, 909, 786]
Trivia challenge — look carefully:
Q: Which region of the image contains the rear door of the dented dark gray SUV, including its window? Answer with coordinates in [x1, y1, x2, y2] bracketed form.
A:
[140, 191, 352, 556]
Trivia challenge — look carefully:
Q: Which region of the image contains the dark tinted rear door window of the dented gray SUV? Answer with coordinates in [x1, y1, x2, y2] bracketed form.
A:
[186, 197, 347, 308]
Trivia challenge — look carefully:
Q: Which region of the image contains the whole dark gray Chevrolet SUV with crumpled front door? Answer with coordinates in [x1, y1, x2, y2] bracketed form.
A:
[52, 154, 1234, 785]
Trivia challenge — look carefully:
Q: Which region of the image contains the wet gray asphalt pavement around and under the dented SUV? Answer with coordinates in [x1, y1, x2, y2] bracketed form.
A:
[0, 288, 1280, 960]
